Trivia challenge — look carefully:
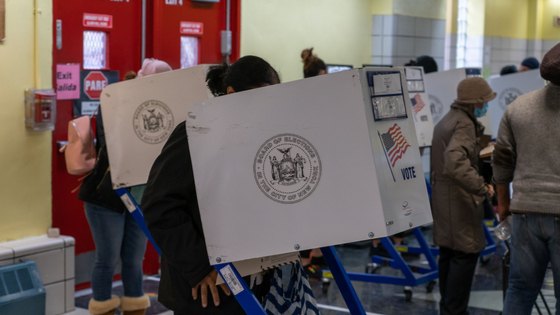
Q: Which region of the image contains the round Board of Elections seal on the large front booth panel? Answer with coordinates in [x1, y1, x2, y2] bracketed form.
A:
[253, 134, 321, 204]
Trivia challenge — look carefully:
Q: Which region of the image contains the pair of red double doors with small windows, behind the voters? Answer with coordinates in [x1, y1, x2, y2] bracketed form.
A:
[52, 0, 241, 288]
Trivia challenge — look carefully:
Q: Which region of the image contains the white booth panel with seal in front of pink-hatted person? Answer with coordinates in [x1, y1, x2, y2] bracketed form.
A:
[101, 65, 212, 189]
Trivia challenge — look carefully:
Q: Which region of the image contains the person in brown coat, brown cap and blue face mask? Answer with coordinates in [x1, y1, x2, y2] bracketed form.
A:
[431, 77, 496, 315]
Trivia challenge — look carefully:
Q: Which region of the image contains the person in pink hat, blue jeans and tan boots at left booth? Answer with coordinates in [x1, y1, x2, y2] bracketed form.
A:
[78, 59, 171, 315]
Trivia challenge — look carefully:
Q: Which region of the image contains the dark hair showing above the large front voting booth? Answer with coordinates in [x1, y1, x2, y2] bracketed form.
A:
[206, 56, 280, 96]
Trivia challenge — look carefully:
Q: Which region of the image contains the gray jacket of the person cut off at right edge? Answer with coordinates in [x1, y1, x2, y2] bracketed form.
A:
[492, 84, 560, 216]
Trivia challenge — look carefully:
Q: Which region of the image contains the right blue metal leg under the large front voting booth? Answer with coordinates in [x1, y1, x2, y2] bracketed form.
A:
[320, 246, 366, 315]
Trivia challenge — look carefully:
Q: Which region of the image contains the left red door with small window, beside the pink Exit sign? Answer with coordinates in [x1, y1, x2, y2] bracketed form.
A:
[52, 0, 158, 287]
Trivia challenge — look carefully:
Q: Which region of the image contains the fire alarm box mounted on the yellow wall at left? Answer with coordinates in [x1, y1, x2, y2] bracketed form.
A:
[25, 89, 56, 131]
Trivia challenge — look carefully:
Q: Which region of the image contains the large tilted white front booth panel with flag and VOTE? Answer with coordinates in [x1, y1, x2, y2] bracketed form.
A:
[187, 68, 432, 264]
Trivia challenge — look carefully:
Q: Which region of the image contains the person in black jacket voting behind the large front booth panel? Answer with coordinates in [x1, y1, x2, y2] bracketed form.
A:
[142, 56, 280, 315]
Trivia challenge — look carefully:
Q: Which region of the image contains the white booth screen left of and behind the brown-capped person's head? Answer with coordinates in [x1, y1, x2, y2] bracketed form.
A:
[425, 68, 492, 135]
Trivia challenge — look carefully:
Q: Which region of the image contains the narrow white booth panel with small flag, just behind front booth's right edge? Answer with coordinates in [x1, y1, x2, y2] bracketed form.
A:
[404, 67, 434, 147]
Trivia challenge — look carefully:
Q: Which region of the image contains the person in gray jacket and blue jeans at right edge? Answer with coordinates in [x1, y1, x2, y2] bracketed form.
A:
[492, 44, 560, 315]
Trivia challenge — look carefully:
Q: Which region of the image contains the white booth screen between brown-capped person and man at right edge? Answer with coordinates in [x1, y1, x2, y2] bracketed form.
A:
[488, 69, 545, 138]
